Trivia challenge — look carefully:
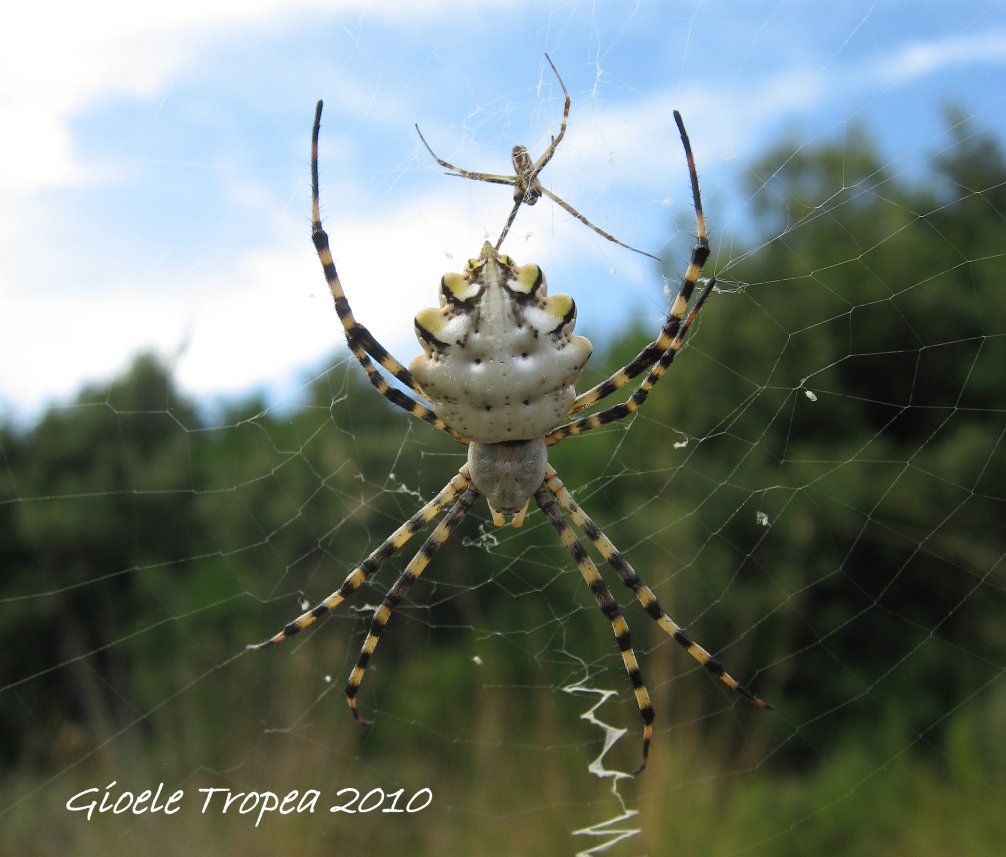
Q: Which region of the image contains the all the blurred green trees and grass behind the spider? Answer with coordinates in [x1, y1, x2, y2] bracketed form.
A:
[0, 122, 1006, 857]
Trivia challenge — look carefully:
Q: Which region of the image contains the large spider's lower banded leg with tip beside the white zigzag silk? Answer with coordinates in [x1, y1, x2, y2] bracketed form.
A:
[534, 482, 653, 774]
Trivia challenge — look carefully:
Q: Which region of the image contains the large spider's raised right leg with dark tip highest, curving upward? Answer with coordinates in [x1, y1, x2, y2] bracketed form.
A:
[571, 111, 709, 414]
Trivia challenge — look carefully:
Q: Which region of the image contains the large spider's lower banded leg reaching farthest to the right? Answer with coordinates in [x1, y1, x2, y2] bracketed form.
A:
[545, 468, 772, 708]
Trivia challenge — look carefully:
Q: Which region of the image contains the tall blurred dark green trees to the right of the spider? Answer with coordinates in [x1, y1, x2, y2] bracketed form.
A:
[634, 115, 1006, 762]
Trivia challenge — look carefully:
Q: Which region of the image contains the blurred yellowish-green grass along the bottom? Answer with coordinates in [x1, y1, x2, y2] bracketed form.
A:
[0, 675, 1006, 857]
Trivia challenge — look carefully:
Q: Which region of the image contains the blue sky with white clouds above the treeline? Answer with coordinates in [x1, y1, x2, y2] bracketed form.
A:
[0, 0, 1006, 422]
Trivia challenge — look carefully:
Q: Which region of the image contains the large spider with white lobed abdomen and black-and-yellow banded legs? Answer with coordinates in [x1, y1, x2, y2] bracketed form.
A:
[248, 95, 771, 773]
